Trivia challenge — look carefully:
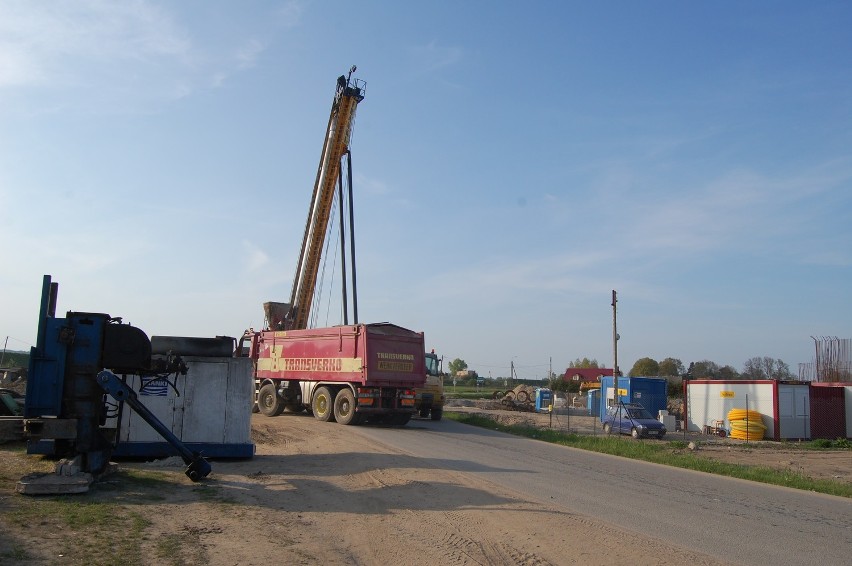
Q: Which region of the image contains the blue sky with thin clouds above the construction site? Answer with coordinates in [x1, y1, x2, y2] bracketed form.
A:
[0, 0, 852, 378]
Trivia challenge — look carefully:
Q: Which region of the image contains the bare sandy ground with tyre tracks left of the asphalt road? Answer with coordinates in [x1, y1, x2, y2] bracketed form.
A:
[130, 415, 736, 566]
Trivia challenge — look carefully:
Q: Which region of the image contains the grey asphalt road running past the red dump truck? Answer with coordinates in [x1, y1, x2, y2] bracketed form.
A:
[352, 420, 852, 566]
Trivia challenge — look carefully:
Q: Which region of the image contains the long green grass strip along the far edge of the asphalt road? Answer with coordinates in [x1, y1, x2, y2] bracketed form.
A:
[444, 412, 852, 498]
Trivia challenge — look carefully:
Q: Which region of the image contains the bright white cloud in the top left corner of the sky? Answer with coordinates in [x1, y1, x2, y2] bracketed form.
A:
[0, 0, 282, 108]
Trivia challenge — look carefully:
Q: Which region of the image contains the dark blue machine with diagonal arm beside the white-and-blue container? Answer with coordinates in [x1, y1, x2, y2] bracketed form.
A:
[24, 275, 210, 481]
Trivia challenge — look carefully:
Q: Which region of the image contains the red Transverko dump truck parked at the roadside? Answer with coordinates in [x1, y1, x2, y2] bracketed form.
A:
[237, 323, 426, 425]
